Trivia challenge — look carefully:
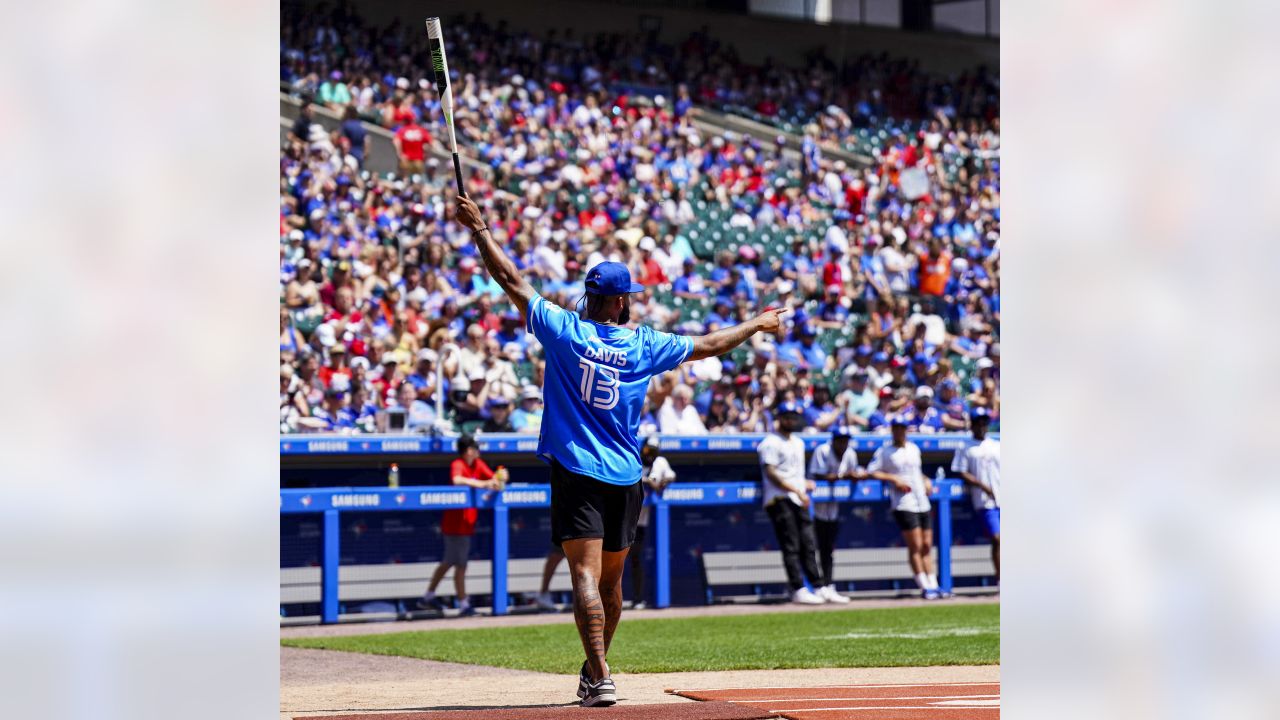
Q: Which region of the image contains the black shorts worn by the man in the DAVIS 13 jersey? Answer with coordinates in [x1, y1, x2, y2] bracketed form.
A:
[552, 460, 644, 552]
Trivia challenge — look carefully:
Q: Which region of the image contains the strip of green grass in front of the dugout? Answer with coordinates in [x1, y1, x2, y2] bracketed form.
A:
[282, 603, 1000, 673]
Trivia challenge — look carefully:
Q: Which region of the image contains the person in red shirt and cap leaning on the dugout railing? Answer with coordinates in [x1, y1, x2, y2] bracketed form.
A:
[417, 436, 507, 616]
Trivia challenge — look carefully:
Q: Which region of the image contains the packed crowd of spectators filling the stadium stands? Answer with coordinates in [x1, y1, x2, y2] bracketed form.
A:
[280, 8, 1000, 434]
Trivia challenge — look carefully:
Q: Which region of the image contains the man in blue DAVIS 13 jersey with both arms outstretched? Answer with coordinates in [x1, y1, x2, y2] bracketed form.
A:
[457, 197, 786, 707]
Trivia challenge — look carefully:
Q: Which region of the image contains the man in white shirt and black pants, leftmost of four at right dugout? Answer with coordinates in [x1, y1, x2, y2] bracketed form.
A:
[756, 400, 827, 605]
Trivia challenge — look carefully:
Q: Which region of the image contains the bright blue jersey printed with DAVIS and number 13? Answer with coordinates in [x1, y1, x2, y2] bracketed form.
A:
[527, 295, 694, 486]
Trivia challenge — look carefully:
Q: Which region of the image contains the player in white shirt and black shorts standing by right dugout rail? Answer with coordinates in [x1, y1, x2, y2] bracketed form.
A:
[867, 415, 942, 600]
